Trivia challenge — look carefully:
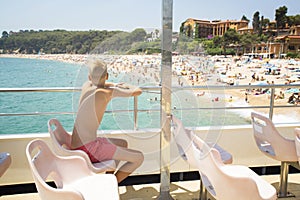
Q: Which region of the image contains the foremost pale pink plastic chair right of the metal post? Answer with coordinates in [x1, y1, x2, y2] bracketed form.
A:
[192, 135, 277, 200]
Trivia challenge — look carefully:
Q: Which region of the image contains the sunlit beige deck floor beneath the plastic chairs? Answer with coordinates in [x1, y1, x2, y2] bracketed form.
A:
[0, 173, 300, 200]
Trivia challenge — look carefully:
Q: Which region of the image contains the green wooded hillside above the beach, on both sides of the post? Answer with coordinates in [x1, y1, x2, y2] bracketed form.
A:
[0, 6, 300, 56]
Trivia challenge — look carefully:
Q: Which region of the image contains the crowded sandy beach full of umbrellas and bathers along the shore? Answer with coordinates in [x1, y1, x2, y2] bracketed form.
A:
[0, 54, 300, 121]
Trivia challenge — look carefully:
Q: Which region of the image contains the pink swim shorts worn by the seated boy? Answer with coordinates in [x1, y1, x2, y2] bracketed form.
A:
[75, 138, 117, 163]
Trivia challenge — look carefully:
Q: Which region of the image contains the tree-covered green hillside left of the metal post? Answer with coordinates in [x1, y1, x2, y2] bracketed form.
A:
[0, 29, 159, 54]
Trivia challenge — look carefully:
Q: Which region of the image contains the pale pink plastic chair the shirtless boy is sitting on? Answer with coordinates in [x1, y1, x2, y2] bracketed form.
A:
[48, 119, 116, 173]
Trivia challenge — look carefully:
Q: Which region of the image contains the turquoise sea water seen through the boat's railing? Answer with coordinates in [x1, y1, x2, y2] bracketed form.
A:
[0, 58, 250, 135]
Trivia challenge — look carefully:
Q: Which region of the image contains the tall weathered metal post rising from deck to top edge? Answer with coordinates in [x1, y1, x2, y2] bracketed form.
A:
[158, 0, 173, 200]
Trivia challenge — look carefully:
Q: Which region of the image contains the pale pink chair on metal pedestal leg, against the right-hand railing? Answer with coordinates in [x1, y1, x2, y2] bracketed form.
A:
[251, 112, 300, 197]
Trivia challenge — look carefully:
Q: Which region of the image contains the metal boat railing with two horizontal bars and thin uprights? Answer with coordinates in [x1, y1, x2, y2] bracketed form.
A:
[0, 84, 300, 129]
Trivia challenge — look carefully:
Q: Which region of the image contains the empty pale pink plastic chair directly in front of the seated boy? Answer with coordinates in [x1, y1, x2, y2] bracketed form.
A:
[26, 140, 119, 200]
